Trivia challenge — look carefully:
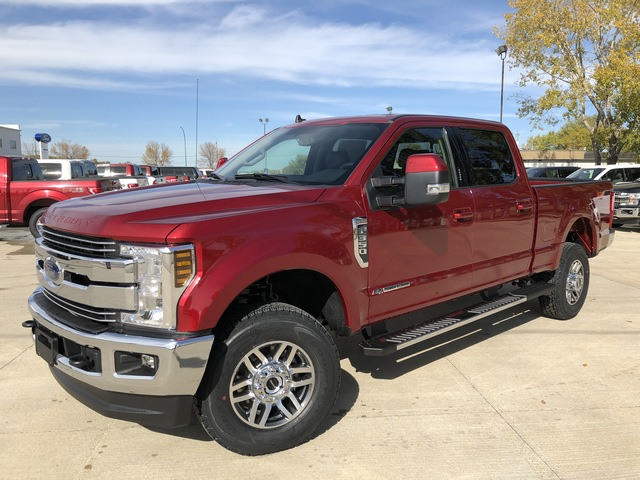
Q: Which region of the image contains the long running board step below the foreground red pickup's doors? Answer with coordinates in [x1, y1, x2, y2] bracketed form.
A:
[360, 282, 553, 356]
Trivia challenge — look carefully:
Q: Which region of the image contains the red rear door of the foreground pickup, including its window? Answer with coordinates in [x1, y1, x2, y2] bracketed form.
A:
[455, 128, 536, 289]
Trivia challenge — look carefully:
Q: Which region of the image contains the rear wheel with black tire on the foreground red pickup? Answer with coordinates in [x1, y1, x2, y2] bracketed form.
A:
[539, 243, 590, 320]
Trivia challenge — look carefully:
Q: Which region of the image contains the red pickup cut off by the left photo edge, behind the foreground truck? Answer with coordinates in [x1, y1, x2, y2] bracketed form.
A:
[0, 157, 119, 237]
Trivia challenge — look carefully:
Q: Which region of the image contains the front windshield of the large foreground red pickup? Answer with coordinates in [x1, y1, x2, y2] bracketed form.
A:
[216, 123, 387, 185]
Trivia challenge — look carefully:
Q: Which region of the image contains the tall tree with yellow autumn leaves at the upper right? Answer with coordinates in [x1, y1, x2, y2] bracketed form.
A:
[496, 0, 640, 164]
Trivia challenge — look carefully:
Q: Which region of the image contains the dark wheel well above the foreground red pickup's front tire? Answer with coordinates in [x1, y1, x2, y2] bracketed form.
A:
[216, 270, 349, 335]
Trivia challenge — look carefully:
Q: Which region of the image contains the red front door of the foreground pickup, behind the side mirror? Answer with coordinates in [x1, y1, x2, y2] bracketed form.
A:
[367, 125, 474, 320]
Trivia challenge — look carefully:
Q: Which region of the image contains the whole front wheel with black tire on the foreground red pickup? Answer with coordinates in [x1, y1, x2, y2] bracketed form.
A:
[199, 303, 340, 455]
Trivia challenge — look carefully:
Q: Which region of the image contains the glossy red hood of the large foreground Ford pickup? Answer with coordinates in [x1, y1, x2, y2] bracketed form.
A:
[43, 181, 325, 242]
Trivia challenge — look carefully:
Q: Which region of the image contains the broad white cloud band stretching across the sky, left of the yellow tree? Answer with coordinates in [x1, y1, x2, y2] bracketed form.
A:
[0, 8, 512, 90]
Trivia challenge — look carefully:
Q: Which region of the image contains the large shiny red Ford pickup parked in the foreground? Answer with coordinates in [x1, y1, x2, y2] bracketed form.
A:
[24, 115, 614, 455]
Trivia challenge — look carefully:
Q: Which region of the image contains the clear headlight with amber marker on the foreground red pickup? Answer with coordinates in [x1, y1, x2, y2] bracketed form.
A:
[120, 245, 195, 329]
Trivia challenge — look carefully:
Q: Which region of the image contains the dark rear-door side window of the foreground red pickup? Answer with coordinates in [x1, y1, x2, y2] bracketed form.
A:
[459, 128, 516, 185]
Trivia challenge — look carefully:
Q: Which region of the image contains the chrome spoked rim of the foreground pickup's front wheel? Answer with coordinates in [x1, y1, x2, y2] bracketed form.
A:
[229, 342, 315, 429]
